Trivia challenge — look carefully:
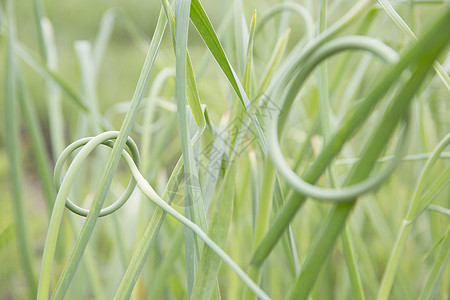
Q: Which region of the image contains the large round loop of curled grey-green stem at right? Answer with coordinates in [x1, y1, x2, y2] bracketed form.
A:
[268, 36, 400, 202]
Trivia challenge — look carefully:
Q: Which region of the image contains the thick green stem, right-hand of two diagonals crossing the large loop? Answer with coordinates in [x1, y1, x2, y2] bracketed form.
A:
[290, 9, 450, 299]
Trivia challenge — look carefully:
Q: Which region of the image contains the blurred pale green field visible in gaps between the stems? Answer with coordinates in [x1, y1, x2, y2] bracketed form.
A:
[0, 0, 450, 300]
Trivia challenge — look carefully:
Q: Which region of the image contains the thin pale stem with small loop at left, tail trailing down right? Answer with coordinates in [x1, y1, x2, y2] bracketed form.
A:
[37, 131, 270, 299]
